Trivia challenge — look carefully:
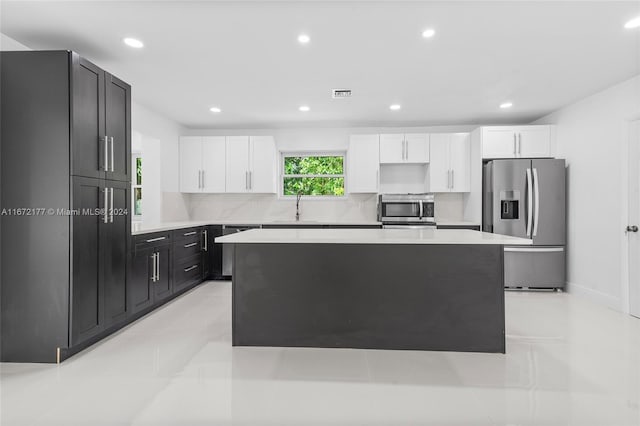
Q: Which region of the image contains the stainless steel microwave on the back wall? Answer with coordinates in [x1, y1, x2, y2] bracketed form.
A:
[378, 194, 435, 223]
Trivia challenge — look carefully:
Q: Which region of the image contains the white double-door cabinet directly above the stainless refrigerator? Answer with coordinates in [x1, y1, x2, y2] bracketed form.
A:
[482, 126, 554, 158]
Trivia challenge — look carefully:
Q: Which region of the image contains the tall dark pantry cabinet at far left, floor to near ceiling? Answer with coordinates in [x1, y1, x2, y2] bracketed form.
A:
[0, 51, 131, 362]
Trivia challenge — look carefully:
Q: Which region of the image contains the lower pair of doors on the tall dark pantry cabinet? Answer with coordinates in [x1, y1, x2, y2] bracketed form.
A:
[70, 177, 130, 346]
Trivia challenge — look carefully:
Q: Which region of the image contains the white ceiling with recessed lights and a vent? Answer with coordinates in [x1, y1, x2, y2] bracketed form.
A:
[0, 0, 640, 128]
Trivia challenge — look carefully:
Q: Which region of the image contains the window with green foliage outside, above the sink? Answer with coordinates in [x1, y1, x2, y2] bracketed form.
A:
[282, 153, 344, 197]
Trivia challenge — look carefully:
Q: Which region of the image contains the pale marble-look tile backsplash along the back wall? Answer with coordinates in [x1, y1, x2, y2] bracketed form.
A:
[163, 193, 464, 223]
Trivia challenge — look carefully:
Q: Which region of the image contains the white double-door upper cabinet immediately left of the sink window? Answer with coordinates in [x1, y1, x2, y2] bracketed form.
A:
[227, 136, 276, 193]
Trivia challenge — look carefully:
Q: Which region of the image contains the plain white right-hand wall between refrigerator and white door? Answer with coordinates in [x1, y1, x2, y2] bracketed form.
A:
[534, 76, 640, 311]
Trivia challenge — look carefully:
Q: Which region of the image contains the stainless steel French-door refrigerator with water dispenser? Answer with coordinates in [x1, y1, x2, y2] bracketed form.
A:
[482, 159, 566, 289]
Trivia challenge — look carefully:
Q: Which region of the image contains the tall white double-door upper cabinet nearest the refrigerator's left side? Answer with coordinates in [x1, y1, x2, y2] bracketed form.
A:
[429, 133, 471, 192]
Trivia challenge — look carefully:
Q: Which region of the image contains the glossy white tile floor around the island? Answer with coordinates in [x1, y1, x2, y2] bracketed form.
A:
[0, 282, 640, 426]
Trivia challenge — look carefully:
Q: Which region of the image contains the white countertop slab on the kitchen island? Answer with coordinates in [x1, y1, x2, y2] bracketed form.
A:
[215, 229, 533, 245]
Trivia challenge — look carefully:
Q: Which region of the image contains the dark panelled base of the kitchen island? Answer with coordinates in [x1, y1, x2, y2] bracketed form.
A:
[233, 244, 505, 353]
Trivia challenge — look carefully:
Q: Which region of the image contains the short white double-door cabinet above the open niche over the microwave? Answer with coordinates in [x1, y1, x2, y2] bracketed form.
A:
[380, 133, 429, 164]
